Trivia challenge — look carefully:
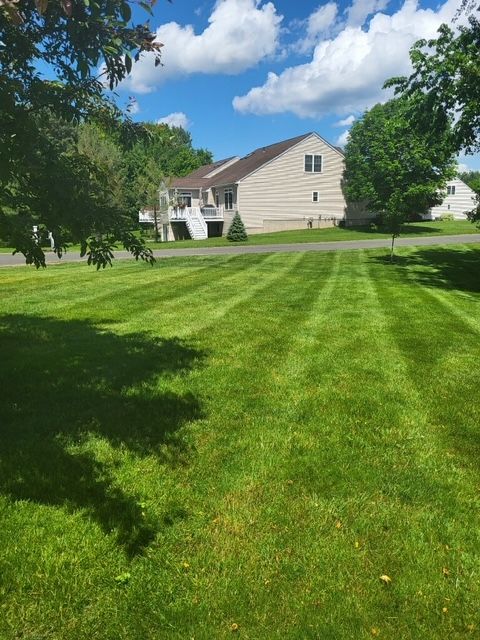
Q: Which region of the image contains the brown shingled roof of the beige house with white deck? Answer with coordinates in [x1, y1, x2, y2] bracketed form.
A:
[172, 132, 344, 189]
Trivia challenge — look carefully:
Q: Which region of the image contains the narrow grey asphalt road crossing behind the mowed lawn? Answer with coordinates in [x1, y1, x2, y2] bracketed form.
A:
[0, 233, 480, 267]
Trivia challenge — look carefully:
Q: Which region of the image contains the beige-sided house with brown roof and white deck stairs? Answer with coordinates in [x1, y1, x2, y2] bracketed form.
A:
[147, 133, 365, 240]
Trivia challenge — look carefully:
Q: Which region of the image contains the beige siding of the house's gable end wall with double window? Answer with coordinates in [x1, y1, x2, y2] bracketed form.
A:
[237, 135, 346, 230]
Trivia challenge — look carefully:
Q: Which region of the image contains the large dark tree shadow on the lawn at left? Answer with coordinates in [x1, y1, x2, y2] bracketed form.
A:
[0, 315, 204, 555]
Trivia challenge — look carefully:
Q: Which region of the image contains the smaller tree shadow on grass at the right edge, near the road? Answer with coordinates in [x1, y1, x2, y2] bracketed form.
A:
[371, 246, 480, 293]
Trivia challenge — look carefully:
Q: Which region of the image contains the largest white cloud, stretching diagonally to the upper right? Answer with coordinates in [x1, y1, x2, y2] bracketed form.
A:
[233, 0, 458, 117]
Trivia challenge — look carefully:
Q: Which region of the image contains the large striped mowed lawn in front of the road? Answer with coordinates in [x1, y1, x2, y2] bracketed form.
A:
[0, 245, 480, 640]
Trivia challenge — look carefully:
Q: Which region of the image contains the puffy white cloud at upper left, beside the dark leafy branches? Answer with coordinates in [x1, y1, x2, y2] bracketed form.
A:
[122, 0, 282, 93]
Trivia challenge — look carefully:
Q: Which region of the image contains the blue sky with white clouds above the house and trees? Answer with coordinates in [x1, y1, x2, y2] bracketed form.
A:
[117, 0, 480, 170]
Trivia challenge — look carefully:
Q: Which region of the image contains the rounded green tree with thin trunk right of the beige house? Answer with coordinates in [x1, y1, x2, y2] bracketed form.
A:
[344, 95, 456, 255]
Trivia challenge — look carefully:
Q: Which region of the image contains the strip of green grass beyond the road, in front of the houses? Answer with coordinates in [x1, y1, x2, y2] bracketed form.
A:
[0, 220, 479, 253]
